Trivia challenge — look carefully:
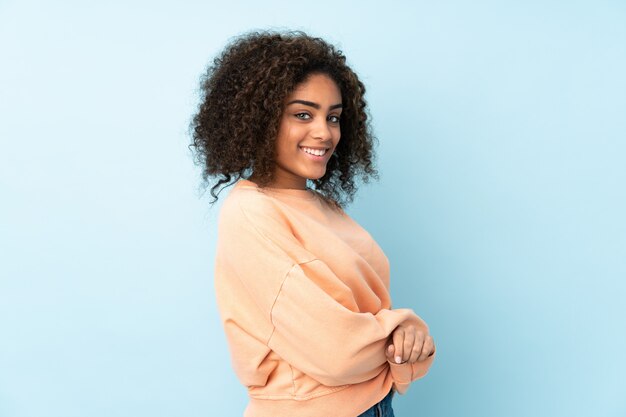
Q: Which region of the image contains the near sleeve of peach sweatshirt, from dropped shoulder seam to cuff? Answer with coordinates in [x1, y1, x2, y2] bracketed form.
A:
[268, 260, 420, 386]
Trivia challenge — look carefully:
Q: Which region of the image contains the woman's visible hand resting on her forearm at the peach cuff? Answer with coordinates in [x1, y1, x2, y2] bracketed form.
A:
[385, 324, 435, 363]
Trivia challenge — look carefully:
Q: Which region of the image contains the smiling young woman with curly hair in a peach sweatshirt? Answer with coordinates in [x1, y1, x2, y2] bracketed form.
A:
[191, 32, 435, 417]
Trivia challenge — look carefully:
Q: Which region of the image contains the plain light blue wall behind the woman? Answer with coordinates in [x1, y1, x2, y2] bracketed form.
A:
[0, 0, 626, 417]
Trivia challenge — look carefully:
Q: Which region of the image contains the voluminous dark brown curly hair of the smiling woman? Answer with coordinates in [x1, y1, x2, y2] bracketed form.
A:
[189, 31, 378, 208]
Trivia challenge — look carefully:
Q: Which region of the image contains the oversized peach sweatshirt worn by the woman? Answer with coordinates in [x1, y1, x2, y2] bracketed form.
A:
[215, 179, 435, 417]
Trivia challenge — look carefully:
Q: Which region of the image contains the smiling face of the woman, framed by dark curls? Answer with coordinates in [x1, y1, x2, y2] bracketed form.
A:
[272, 74, 342, 189]
